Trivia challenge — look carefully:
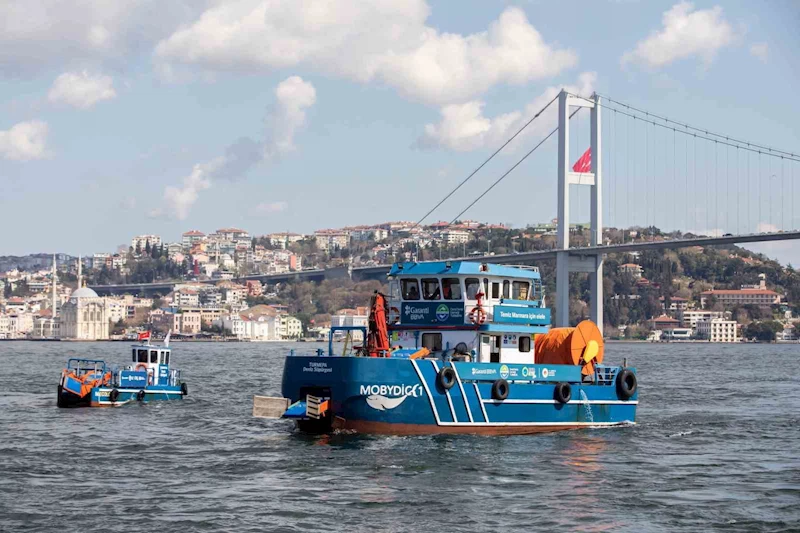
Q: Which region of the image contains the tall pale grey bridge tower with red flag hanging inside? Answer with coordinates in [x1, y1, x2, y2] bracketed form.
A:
[555, 90, 603, 331]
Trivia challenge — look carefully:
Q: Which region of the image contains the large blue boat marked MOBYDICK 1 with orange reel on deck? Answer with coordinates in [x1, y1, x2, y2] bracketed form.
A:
[254, 261, 638, 435]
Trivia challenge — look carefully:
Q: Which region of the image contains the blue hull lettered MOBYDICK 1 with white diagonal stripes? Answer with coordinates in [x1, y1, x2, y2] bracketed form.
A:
[282, 356, 638, 434]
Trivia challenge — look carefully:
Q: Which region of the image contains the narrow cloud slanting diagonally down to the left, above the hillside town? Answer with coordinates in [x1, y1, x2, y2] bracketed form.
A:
[159, 76, 317, 220]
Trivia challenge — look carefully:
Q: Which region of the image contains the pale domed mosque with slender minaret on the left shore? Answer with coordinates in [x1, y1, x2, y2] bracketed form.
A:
[59, 258, 110, 341]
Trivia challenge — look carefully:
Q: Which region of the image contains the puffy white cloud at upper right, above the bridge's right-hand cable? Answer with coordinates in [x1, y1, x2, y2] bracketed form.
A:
[622, 2, 736, 68]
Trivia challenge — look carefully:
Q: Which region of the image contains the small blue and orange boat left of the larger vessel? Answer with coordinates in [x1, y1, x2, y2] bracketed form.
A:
[58, 334, 189, 407]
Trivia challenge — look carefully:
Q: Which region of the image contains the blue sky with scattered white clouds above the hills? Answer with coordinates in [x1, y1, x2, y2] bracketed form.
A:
[0, 0, 800, 264]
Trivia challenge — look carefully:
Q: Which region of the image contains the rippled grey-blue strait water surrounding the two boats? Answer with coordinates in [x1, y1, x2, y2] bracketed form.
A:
[0, 342, 800, 533]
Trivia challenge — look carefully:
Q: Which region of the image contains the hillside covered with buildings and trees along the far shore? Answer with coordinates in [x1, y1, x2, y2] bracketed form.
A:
[0, 220, 800, 342]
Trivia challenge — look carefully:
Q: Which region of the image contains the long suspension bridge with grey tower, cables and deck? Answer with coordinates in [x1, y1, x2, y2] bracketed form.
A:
[92, 90, 800, 326]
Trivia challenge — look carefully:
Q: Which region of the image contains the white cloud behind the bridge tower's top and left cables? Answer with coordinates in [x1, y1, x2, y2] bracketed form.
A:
[417, 72, 597, 152]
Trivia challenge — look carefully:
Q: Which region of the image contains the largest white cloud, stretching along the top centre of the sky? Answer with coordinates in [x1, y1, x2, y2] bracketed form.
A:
[156, 0, 577, 104]
